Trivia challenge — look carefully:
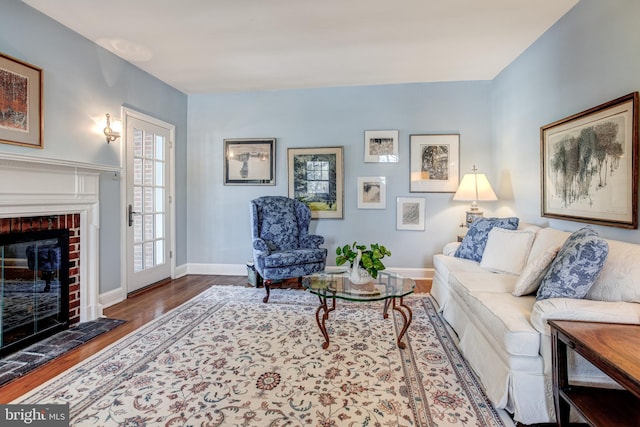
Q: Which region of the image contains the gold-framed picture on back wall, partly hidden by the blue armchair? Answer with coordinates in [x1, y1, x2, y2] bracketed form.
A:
[287, 147, 344, 219]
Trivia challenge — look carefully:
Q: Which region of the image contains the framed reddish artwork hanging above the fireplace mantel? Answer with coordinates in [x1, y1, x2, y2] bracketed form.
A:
[0, 54, 44, 148]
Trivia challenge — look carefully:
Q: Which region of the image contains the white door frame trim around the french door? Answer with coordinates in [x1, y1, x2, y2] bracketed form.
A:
[120, 107, 176, 299]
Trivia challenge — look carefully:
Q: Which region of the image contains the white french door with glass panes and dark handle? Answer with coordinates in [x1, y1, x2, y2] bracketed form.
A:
[123, 111, 173, 293]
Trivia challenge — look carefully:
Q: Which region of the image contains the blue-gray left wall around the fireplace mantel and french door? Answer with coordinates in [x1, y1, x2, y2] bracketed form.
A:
[0, 0, 187, 292]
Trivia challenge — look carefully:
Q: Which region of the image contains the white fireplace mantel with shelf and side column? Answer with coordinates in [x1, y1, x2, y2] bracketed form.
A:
[0, 153, 119, 322]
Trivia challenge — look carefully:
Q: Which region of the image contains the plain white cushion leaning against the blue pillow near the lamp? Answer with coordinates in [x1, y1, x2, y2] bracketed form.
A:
[480, 227, 536, 274]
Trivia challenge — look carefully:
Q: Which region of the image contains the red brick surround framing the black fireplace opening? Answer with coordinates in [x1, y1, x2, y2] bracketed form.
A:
[0, 213, 80, 326]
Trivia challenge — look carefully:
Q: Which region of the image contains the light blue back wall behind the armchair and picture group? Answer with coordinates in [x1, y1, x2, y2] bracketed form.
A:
[187, 81, 492, 268]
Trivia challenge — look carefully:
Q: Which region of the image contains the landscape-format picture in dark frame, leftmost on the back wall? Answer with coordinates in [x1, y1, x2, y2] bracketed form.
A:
[224, 138, 276, 185]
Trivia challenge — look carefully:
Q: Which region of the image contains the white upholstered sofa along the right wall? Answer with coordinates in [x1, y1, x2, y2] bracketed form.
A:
[431, 226, 640, 424]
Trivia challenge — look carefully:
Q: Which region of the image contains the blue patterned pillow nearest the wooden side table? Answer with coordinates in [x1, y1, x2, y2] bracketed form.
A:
[536, 227, 609, 300]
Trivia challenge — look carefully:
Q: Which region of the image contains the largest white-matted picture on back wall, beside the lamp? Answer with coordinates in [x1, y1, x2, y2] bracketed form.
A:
[409, 134, 460, 193]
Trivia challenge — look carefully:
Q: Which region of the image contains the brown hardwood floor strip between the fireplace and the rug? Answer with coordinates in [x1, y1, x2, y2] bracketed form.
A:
[0, 275, 247, 403]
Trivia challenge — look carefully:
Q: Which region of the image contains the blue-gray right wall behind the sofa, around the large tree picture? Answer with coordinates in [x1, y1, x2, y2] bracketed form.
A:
[491, 0, 640, 242]
